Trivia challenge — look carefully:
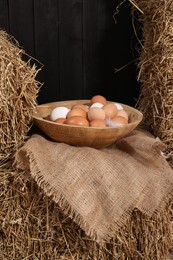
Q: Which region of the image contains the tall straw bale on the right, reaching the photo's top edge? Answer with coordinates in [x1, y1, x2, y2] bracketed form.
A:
[132, 0, 173, 167]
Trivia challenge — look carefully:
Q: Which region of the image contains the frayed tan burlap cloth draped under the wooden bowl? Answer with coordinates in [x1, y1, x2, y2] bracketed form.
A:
[16, 130, 173, 242]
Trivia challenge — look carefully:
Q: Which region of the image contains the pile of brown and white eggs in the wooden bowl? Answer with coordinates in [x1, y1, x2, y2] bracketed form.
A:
[47, 95, 128, 127]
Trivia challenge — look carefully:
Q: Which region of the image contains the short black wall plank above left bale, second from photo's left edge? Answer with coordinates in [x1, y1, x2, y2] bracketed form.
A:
[8, 0, 35, 56]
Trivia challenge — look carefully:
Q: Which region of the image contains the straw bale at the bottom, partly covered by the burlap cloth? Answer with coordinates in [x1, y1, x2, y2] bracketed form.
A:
[0, 167, 172, 260]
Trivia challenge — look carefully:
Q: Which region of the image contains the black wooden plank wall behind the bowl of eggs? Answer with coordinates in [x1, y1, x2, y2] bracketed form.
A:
[0, 0, 139, 105]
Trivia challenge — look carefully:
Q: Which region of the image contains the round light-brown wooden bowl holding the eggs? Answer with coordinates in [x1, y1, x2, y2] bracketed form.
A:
[33, 100, 143, 149]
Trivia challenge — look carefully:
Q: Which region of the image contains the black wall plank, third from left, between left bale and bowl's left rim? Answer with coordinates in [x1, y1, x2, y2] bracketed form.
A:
[34, 0, 61, 103]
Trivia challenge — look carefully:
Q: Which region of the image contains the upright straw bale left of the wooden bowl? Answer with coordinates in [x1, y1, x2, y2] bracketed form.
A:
[0, 31, 41, 169]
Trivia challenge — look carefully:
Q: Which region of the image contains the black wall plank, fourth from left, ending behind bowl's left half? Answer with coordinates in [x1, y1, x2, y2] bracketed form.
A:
[59, 0, 83, 100]
